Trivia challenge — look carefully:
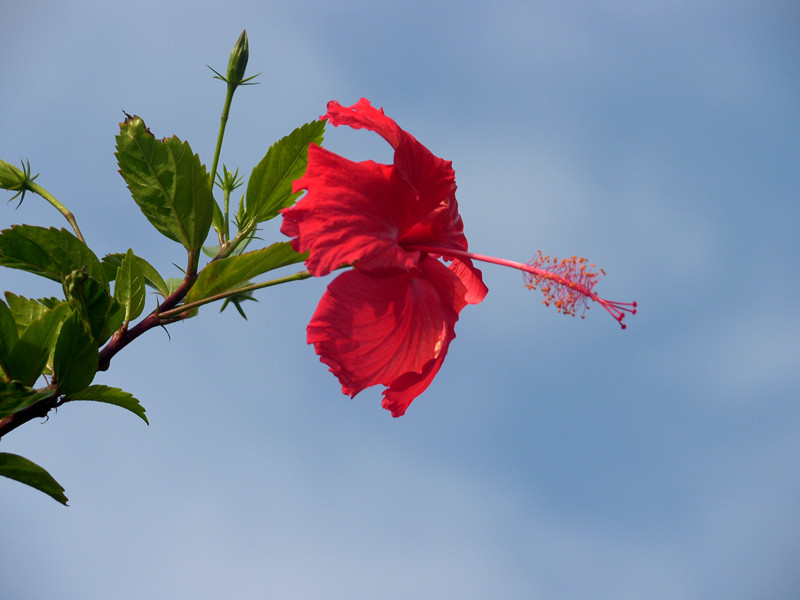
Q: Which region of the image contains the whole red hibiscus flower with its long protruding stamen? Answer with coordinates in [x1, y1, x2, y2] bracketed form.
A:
[281, 98, 635, 417]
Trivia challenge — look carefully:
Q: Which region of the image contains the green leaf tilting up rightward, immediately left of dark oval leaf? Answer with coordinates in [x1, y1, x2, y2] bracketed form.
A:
[7, 302, 69, 386]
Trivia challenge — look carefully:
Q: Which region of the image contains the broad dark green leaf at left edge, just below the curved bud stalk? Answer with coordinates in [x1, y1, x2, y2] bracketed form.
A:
[0, 225, 108, 288]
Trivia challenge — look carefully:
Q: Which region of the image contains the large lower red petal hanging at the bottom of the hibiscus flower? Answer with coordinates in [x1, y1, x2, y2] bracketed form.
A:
[308, 258, 466, 416]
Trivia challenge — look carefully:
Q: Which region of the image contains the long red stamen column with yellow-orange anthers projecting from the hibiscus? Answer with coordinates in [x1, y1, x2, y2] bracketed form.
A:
[409, 246, 636, 329]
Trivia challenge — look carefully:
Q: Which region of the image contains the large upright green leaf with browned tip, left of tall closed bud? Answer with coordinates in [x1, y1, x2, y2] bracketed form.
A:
[116, 117, 214, 251]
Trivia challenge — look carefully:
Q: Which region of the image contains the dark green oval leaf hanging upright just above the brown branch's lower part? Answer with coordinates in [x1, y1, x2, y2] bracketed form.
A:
[53, 311, 99, 394]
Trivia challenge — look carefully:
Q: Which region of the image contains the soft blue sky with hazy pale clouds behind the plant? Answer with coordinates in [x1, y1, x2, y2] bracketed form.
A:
[0, 0, 800, 600]
